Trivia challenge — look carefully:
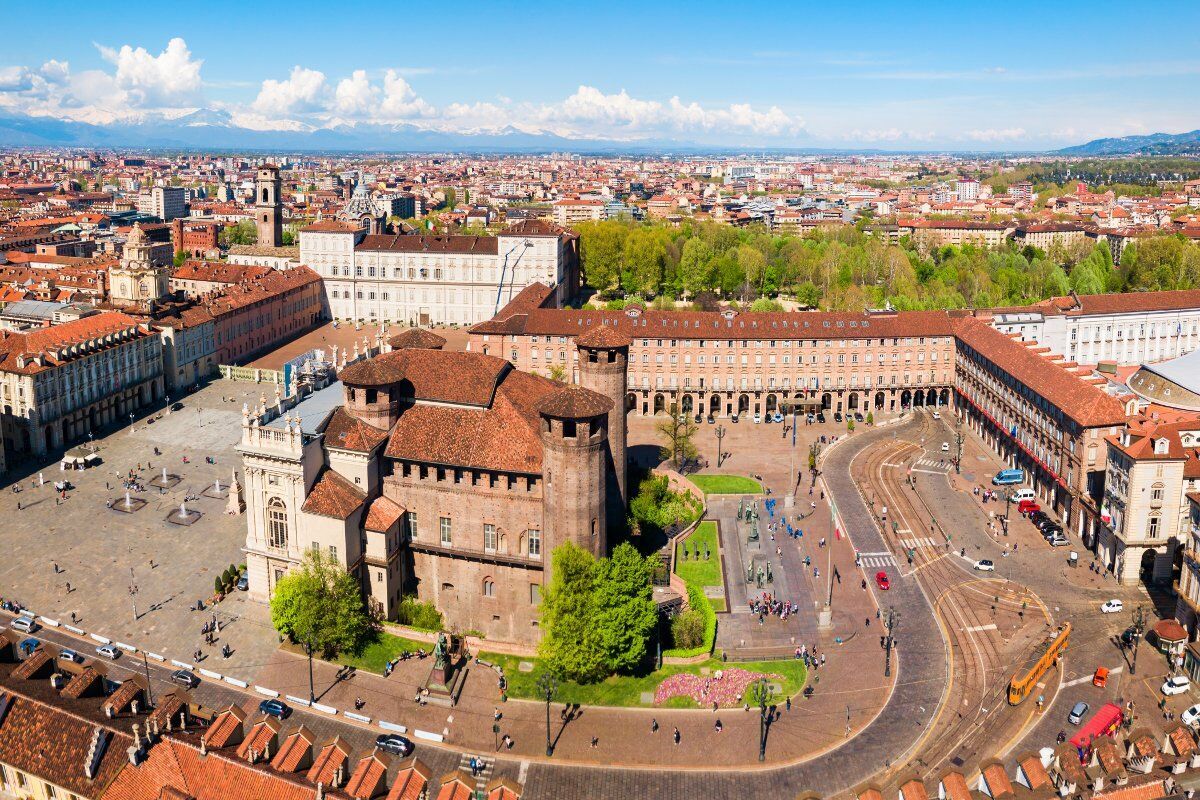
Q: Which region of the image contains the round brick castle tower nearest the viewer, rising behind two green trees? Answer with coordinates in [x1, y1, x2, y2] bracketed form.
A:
[538, 386, 612, 561]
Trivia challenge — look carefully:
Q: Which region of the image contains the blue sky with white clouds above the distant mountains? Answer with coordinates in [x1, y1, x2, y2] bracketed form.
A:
[0, 0, 1200, 150]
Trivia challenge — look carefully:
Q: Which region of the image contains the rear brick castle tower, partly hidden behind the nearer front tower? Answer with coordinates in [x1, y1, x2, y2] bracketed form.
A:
[575, 325, 630, 524]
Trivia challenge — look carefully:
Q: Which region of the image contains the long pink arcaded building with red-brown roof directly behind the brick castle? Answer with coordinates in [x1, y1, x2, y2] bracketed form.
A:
[468, 287, 954, 417]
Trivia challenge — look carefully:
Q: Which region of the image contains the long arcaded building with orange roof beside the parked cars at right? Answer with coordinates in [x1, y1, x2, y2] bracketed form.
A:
[954, 317, 1135, 553]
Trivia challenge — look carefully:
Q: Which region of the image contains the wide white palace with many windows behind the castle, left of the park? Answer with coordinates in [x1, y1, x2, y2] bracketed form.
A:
[300, 221, 580, 325]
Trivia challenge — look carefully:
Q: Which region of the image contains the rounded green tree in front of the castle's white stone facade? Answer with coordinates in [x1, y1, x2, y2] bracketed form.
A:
[271, 549, 373, 658]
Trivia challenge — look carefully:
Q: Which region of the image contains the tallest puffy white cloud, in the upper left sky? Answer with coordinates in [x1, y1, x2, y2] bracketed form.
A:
[97, 36, 204, 108]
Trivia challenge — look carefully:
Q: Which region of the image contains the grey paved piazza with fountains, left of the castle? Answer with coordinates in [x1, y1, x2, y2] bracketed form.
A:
[0, 380, 277, 678]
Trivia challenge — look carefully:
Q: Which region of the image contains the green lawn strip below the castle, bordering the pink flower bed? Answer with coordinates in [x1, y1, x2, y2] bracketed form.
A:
[478, 652, 806, 709]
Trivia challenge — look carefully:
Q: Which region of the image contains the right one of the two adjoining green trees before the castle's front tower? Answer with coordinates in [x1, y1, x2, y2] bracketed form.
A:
[592, 542, 658, 673]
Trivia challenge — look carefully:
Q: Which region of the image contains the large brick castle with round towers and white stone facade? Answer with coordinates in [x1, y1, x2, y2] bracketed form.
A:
[238, 329, 629, 644]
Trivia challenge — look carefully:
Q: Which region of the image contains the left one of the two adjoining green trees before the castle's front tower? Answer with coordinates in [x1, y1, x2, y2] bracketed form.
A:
[538, 541, 608, 682]
